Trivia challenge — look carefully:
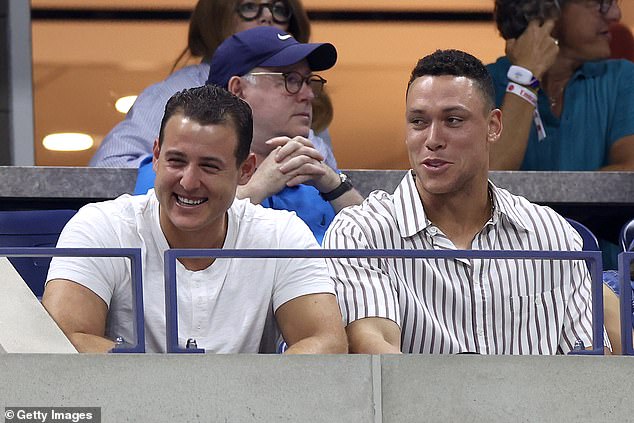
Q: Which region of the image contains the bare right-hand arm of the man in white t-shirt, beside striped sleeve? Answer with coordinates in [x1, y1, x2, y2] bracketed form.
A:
[275, 294, 348, 354]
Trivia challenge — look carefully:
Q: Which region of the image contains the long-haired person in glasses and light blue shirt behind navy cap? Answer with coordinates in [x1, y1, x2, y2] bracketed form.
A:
[90, 0, 337, 169]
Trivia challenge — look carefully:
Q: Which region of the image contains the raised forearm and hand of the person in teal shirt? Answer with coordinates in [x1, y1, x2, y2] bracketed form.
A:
[489, 20, 559, 170]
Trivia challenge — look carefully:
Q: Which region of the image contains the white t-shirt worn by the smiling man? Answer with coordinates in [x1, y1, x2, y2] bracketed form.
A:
[47, 190, 335, 353]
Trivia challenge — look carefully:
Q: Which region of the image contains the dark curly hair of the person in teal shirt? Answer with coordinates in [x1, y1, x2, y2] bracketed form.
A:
[493, 0, 566, 40]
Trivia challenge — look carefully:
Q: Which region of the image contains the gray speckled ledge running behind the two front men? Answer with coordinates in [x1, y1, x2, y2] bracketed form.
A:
[0, 166, 634, 205]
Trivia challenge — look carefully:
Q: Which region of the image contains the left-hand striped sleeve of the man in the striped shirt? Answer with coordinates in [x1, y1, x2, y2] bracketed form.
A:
[323, 211, 401, 326]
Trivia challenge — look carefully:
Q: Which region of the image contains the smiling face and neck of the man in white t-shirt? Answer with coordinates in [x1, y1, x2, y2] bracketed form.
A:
[153, 113, 254, 248]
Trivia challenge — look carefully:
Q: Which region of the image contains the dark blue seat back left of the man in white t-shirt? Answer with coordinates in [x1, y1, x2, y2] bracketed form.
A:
[0, 210, 76, 297]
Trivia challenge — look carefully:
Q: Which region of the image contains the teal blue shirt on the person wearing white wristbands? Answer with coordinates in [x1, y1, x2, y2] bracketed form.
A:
[487, 57, 634, 171]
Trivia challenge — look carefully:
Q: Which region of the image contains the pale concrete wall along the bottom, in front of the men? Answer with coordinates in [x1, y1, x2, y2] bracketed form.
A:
[0, 354, 634, 423]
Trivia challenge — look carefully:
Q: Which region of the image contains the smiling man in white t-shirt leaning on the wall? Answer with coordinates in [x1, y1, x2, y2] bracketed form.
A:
[42, 86, 347, 353]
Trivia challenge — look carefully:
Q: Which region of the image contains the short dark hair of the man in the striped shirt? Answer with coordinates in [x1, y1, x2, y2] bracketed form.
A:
[407, 50, 495, 111]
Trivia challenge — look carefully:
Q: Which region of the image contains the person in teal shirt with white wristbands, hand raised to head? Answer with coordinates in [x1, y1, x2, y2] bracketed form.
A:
[488, 0, 634, 171]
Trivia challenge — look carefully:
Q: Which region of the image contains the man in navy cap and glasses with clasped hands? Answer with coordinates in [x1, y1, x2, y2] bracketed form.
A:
[136, 27, 363, 242]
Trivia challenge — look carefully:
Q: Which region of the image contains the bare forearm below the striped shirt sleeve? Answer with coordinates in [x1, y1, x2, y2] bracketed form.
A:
[346, 317, 401, 354]
